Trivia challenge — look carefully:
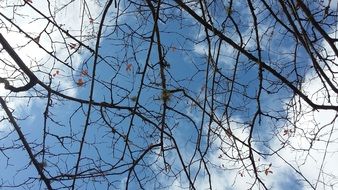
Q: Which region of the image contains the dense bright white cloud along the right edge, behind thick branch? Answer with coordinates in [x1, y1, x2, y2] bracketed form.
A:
[266, 27, 338, 189]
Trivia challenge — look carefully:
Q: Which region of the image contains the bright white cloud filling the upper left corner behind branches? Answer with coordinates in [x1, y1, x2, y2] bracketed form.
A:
[0, 0, 102, 128]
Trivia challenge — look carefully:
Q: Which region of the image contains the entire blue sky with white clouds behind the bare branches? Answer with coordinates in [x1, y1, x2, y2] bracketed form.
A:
[0, 0, 338, 189]
